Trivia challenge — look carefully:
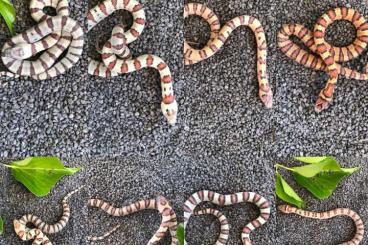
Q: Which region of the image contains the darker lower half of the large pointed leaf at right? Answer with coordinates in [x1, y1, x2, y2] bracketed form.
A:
[293, 168, 359, 200]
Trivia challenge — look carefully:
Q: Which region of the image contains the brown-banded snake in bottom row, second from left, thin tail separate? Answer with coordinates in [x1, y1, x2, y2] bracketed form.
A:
[87, 196, 179, 245]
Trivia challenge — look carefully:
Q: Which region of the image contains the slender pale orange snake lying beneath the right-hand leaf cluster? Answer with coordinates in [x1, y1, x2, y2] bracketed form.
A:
[278, 205, 364, 245]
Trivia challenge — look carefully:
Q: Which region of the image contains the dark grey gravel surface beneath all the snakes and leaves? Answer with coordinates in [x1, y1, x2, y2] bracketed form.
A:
[0, 0, 368, 245]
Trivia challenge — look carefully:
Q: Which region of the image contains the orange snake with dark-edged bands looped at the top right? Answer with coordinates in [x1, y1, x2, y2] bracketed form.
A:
[277, 7, 368, 112]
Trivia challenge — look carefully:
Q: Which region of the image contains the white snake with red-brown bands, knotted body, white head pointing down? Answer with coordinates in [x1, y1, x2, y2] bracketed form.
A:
[87, 0, 178, 125]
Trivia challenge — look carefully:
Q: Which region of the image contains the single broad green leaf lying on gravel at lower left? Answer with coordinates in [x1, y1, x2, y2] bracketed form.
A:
[6, 157, 80, 197]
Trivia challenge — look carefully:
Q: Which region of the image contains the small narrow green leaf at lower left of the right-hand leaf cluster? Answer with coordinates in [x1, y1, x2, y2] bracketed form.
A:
[276, 173, 304, 208]
